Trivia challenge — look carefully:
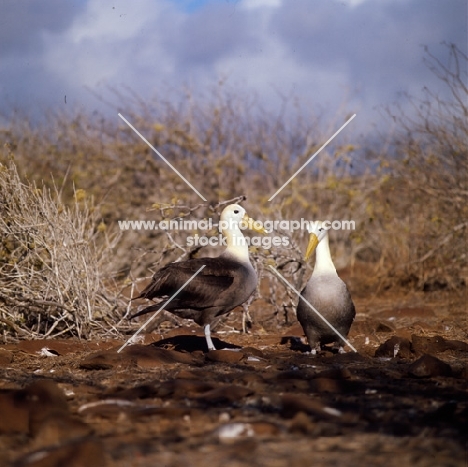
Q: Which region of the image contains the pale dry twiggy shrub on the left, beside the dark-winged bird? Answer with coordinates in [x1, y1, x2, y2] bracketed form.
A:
[0, 155, 120, 340]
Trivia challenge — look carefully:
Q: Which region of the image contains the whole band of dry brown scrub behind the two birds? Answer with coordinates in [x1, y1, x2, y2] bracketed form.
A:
[0, 45, 468, 340]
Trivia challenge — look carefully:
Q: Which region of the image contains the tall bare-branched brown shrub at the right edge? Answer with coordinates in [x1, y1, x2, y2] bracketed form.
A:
[374, 44, 468, 290]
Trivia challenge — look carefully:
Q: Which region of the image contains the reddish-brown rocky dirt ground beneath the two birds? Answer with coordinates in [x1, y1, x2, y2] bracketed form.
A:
[0, 292, 468, 467]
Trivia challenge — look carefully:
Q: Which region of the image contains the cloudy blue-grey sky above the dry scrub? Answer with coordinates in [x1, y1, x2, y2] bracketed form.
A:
[0, 0, 467, 137]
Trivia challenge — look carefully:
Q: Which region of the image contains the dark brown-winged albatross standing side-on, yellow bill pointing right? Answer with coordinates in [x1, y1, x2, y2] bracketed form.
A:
[131, 204, 265, 350]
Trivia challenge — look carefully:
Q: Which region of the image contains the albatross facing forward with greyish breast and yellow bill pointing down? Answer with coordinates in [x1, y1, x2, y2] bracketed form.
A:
[297, 222, 356, 353]
